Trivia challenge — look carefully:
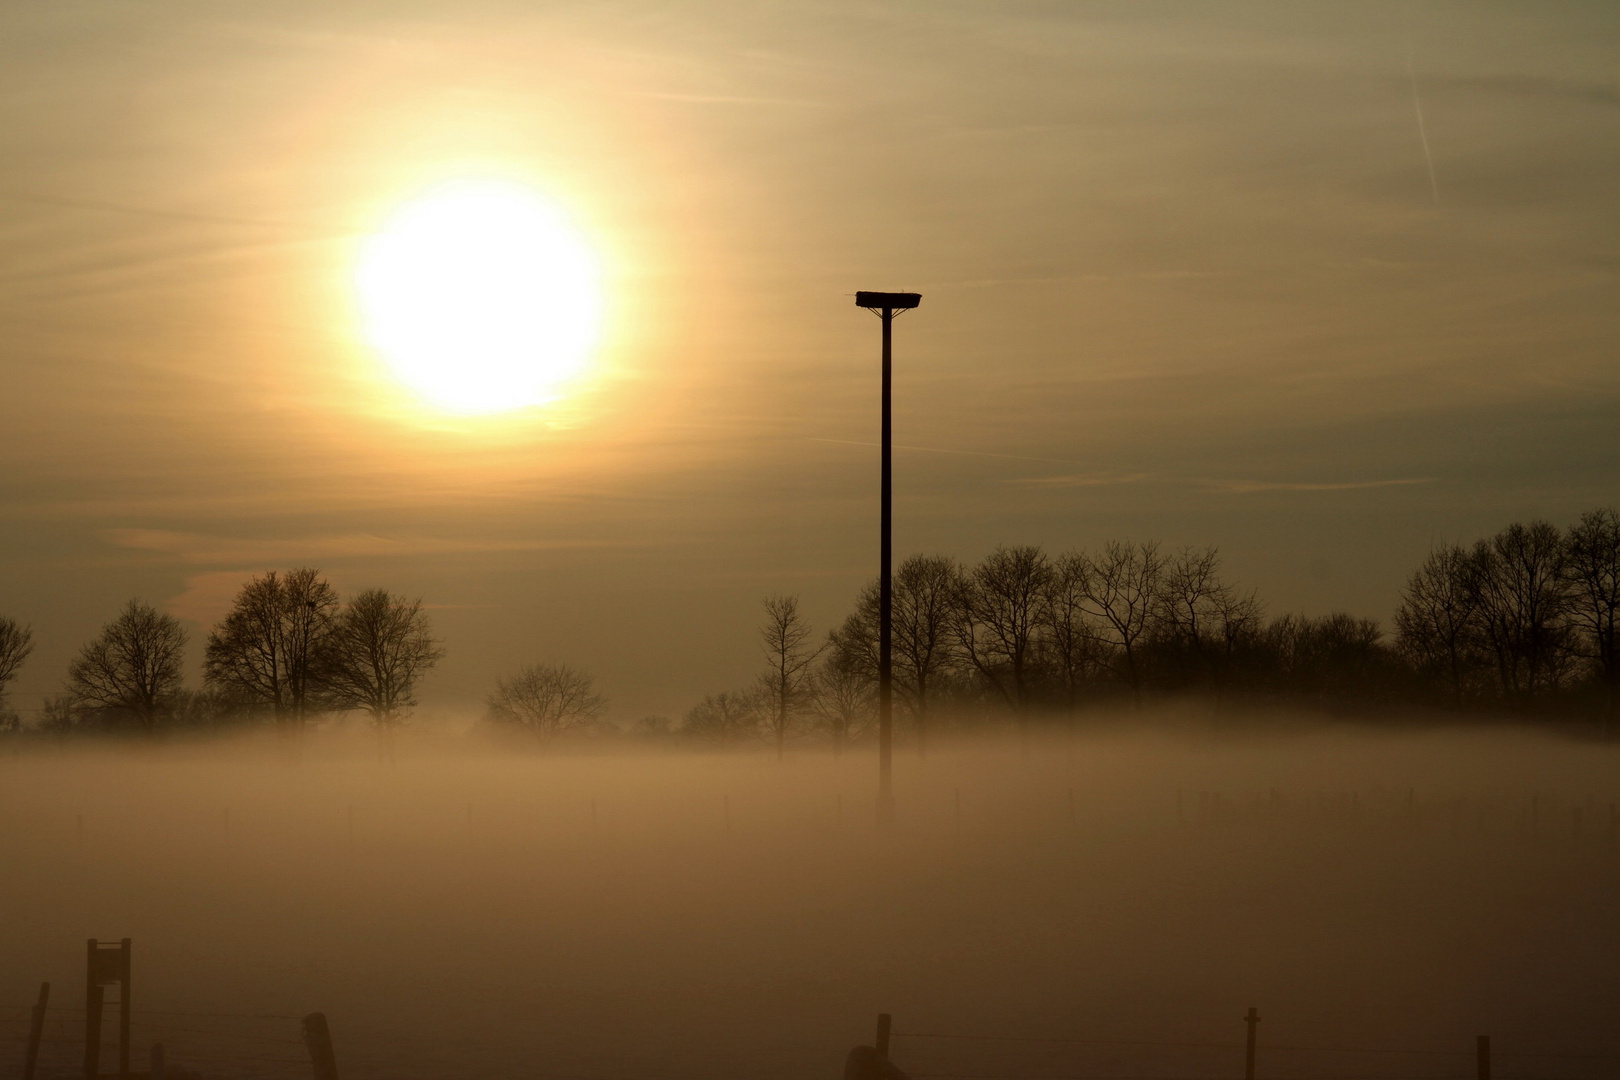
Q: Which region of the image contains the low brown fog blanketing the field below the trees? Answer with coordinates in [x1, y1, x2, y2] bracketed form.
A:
[0, 730, 1620, 1080]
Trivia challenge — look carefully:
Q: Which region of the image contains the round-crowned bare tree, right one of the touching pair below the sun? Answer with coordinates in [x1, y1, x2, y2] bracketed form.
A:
[319, 589, 444, 727]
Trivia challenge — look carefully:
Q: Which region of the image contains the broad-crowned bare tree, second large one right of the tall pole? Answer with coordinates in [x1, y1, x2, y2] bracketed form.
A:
[953, 547, 1051, 717]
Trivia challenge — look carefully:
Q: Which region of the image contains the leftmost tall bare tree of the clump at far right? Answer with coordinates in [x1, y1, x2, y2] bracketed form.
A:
[1395, 544, 1481, 708]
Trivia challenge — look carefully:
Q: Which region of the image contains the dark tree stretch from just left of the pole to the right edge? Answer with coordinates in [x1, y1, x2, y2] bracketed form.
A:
[657, 508, 1620, 753]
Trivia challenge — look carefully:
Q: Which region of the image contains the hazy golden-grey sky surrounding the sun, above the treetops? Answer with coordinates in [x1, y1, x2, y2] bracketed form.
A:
[0, 0, 1620, 721]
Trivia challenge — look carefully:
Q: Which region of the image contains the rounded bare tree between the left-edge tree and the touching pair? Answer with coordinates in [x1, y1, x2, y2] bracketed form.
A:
[66, 601, 186, 732]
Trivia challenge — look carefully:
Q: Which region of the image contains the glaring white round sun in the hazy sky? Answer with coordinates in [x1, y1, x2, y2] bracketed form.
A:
[356, 181, 601, 413]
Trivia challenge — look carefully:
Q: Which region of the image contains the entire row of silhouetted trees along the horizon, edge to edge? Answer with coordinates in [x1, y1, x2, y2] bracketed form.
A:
[0, 508, 1620, 753]
